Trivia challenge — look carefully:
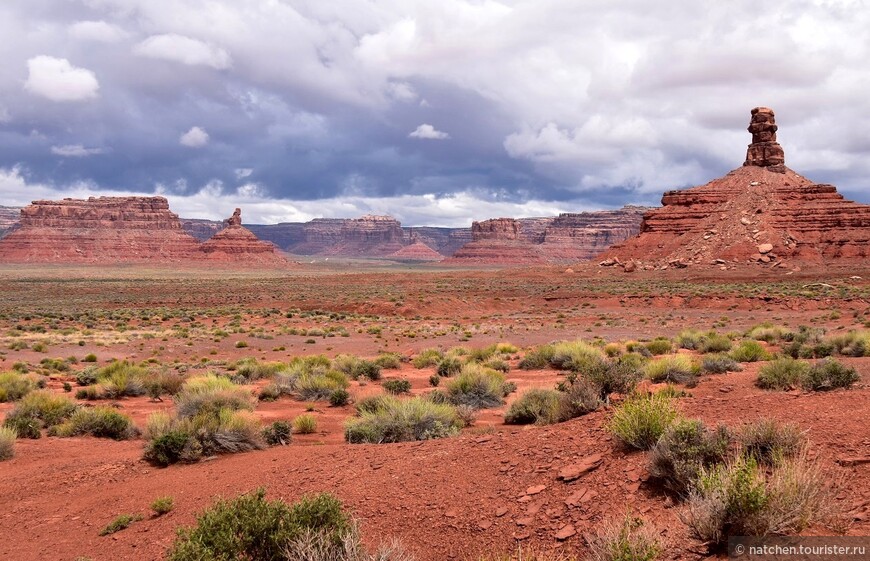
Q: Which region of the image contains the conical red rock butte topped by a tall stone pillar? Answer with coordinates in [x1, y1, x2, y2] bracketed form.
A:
[602, 107, 870, 268]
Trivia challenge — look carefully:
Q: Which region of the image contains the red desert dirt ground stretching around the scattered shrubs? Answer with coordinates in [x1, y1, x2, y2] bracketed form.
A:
[0, 266, 870, 561]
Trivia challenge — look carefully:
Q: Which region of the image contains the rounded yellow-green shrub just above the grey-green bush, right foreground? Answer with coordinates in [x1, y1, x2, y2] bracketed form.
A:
[608, 394, 678, 450]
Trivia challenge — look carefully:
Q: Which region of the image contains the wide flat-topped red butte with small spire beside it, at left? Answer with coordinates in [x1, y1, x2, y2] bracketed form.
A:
[0, 197, 287, 266]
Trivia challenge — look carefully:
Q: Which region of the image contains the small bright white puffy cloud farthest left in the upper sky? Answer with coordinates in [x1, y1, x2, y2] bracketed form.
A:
[24, 55, 100, 101]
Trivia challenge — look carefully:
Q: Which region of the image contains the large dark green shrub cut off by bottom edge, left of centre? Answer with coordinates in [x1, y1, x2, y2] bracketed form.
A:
[167, 489, 351, 561]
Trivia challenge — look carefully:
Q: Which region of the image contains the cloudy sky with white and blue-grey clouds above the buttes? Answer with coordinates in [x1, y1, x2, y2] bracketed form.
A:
[0, 0, 870, 226]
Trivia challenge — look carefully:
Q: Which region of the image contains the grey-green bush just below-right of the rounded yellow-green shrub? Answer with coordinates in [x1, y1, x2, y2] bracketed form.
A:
[649, 419, 731, 494]
